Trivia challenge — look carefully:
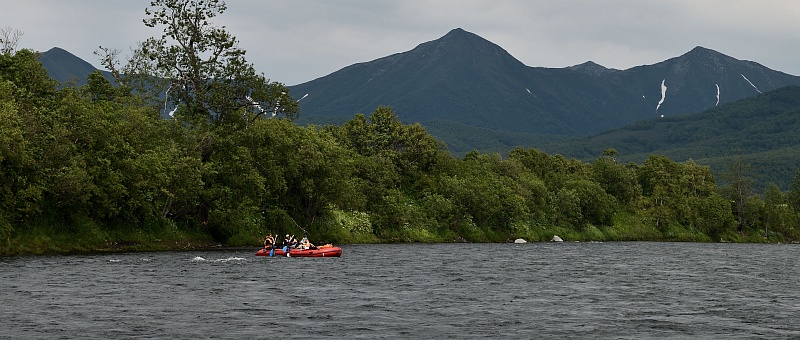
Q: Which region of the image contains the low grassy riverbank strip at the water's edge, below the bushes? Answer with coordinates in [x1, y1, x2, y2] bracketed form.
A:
[0, 219, 789, 256]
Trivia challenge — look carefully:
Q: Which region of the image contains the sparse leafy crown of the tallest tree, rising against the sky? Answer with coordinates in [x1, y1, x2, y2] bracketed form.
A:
[102, 0, 298, 125]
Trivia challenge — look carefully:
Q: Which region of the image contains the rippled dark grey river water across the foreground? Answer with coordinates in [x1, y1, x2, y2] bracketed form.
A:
[0, 242, 800, 339]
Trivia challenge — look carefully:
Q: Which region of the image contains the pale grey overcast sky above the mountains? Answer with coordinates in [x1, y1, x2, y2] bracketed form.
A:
[0, 0, 800, 85]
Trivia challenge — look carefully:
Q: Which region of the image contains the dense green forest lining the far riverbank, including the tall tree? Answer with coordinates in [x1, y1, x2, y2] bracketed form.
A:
[0, 1, 800, 254]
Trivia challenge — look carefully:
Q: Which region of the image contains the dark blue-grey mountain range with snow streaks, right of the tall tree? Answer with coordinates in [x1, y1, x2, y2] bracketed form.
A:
[290, 29, 800, 153]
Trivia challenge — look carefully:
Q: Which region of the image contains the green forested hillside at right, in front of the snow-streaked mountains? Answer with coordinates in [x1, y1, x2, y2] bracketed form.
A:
[556, 86, 800, 190]
